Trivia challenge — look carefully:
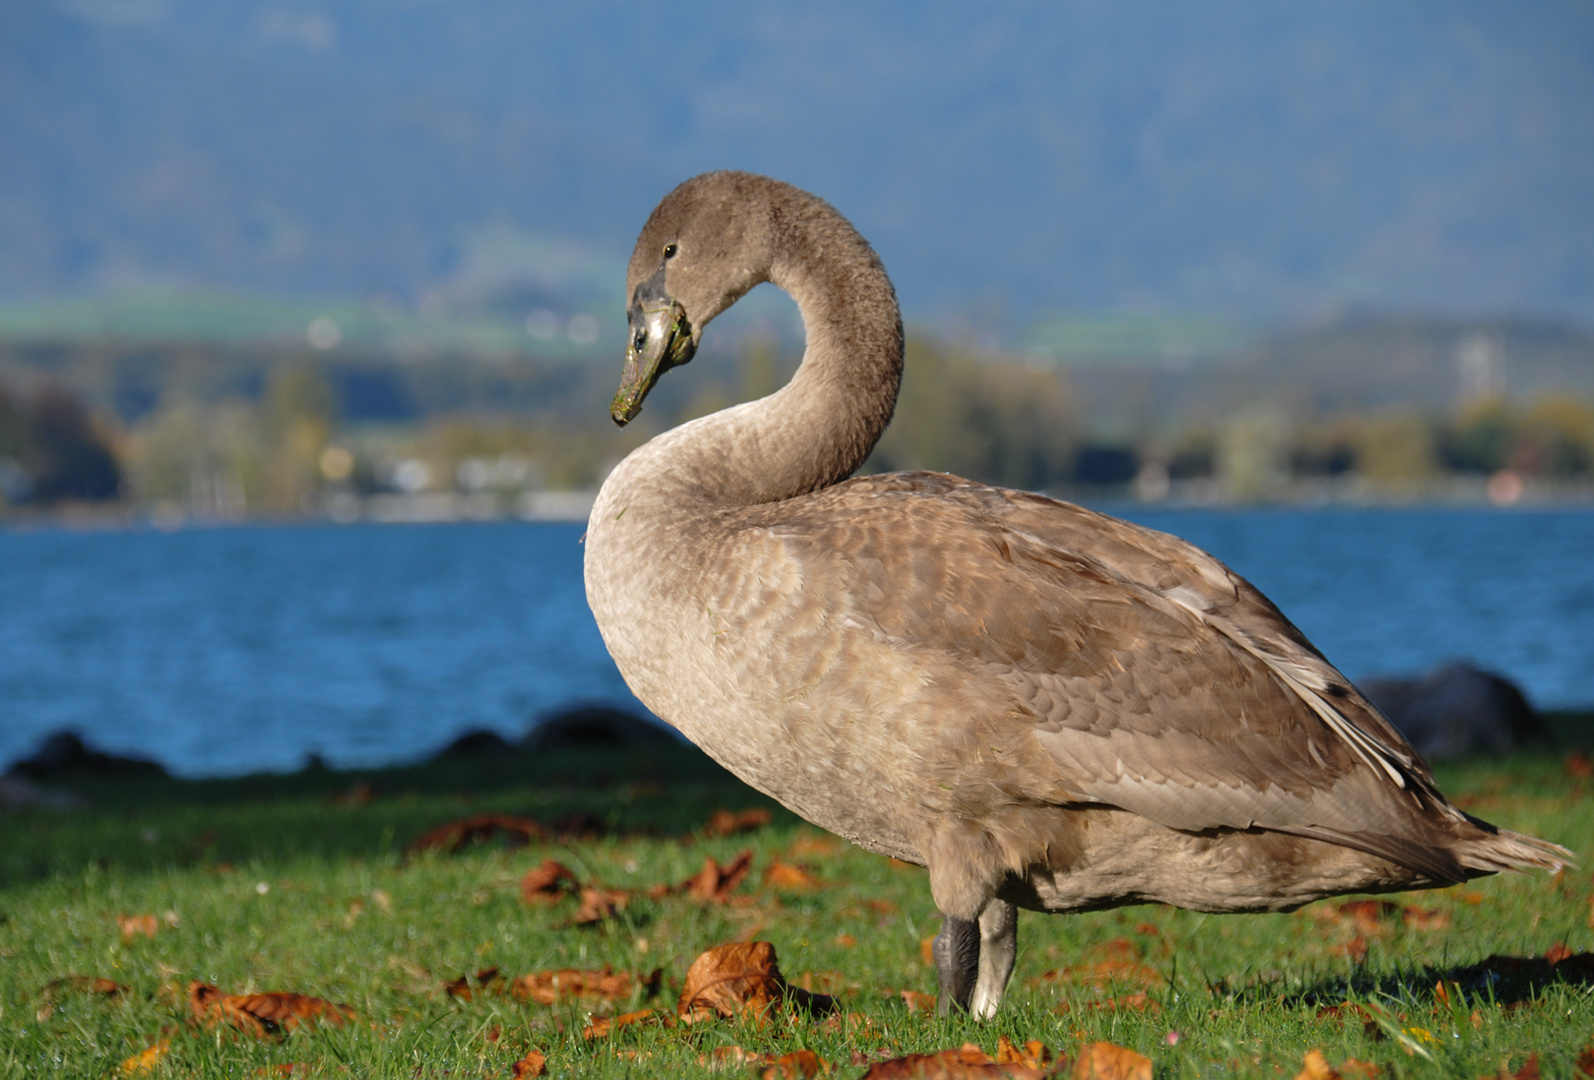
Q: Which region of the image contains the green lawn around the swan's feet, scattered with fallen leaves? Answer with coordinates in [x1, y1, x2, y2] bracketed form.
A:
[0, 735, 1594, 1078]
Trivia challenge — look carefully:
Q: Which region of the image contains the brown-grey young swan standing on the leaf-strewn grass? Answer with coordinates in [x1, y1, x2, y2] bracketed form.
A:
[587, 172, 1570, 1016]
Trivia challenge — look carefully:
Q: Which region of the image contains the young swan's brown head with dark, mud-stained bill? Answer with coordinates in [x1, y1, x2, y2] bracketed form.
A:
[609, 172, 777, 427]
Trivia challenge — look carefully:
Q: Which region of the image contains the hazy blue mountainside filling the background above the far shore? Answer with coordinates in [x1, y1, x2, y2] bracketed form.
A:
[0, 0, 1594, 330]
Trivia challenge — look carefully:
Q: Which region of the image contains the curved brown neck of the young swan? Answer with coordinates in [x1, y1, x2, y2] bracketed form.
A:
[644, 208, 902, 507]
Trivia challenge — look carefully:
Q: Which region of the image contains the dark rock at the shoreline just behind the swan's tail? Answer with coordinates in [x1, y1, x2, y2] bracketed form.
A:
[1361, 663, 1549, 761]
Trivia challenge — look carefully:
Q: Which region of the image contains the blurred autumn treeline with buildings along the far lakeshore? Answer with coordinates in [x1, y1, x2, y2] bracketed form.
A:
[0, 316, 1594, 518]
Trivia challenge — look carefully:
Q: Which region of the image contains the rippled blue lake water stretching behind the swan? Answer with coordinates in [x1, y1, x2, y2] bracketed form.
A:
[0, 510, 1594, 776]
